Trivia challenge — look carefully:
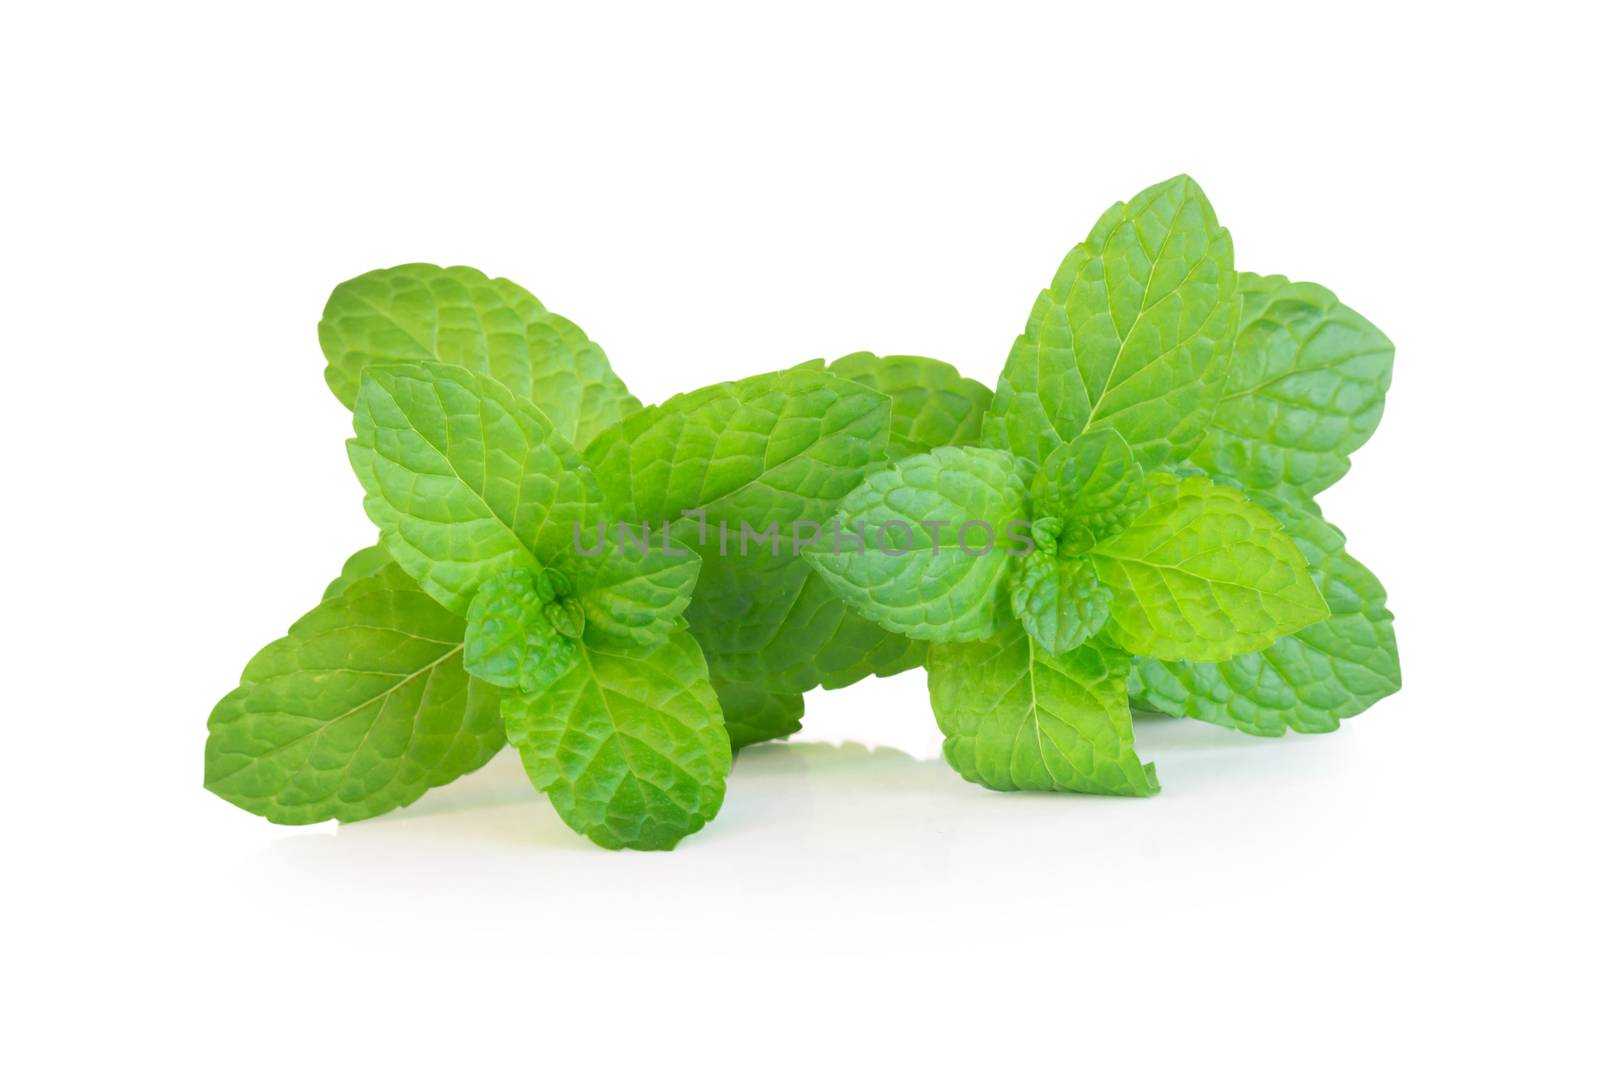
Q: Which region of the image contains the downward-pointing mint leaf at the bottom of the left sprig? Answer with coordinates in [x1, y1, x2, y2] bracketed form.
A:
[501, 630, 733, 849]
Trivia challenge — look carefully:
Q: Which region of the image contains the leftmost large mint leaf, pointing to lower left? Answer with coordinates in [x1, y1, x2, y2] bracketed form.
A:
[205, 553, 506, 824]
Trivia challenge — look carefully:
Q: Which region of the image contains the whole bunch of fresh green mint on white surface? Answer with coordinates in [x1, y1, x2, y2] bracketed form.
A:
[206, 176, 1400, 849]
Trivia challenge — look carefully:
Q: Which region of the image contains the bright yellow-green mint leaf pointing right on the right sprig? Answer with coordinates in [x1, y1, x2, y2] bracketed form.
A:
[1090, 478, 1328, 661]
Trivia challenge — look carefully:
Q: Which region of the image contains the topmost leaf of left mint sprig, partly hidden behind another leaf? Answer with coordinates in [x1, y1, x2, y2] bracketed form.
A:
[317, 262, 640, 446]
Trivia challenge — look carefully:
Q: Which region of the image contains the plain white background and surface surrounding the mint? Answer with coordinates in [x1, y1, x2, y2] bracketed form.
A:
[0, 3, 1600, 1064]
